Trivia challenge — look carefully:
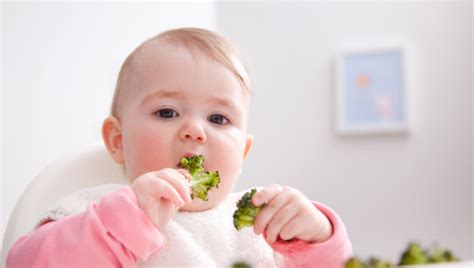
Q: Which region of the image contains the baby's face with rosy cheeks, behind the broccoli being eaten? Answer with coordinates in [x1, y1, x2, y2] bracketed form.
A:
[120, 44, 252, 211]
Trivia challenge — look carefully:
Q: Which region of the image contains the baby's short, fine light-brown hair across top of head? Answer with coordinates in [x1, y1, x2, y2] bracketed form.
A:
[111, 28, 252, 118]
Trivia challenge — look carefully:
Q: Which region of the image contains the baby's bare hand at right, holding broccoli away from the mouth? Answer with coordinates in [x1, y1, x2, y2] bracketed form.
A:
[252, 184, 332, 243]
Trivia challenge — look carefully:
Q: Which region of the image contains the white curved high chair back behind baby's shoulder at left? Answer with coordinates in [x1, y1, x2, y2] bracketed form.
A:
[2, 144, 128, 265]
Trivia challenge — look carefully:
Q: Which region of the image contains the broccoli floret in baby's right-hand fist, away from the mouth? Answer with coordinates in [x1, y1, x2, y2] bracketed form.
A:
[233, 188, 264, 231]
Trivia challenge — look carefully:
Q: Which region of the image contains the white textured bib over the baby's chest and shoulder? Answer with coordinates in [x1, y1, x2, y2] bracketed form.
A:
[42, 184, 283, 267]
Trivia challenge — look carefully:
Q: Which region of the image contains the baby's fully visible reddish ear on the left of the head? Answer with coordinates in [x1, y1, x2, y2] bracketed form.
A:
[102, 116, 124, 164]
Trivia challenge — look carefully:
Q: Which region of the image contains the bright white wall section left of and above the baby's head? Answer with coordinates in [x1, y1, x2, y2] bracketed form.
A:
[0, 2, 216, 244]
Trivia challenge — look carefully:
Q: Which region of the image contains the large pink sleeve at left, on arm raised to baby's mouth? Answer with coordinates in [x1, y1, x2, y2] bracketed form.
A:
[6, 187, 164, 267]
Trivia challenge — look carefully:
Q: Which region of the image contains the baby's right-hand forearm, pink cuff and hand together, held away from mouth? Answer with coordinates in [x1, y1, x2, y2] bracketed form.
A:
[253, 185, 352, 268]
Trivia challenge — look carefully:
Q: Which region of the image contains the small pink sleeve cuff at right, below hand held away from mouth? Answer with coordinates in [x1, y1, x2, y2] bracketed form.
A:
[271, 202, 352, 268]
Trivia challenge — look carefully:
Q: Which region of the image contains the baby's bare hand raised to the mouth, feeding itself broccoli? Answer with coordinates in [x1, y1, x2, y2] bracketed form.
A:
[131, 168, 191, 230]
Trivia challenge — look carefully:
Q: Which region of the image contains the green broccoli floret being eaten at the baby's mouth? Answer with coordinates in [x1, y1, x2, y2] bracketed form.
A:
[180, 155, 220, 201]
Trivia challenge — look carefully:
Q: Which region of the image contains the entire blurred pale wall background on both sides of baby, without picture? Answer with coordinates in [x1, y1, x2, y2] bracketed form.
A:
[0, 1, 474, 261]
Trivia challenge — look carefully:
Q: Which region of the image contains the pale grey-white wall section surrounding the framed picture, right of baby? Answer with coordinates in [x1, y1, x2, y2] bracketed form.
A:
[217, 1, 473, 261]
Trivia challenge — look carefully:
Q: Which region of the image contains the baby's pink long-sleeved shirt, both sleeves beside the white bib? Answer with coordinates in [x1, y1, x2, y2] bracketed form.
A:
[6, 187, 352, 268]
